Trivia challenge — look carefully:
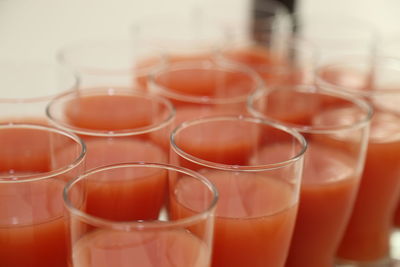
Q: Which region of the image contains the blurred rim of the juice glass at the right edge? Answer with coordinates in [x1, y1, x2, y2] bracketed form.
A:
[315, 55, 400, 98]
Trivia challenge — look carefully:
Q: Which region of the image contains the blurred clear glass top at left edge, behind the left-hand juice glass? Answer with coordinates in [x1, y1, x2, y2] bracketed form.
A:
[0, 59, 78, 124]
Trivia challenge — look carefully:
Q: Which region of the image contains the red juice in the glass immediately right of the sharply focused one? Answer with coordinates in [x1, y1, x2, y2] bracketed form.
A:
[284, 143, 360, 267]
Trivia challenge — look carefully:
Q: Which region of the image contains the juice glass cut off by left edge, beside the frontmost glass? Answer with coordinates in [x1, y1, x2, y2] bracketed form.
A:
[0, 123, 86, 267]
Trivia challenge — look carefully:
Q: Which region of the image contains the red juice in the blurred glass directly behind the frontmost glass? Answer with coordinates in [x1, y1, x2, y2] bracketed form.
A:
[60, 91, 168, 221]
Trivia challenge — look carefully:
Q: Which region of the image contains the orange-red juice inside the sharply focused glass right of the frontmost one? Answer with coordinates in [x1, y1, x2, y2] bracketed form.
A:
[172, 169, 297, 267]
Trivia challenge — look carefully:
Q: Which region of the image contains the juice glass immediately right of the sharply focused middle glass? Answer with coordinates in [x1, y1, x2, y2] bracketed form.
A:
[249, 86, 372, 267]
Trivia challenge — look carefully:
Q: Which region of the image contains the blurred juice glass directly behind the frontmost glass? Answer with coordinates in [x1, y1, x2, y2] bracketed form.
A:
[47, 87, 175, 169]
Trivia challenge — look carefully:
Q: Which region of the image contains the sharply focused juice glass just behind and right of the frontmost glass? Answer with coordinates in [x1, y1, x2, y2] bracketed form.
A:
[170, 116, 306, 267]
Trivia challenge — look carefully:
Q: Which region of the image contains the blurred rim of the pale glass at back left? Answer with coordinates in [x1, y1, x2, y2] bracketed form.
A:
[56, 38, 165, 76]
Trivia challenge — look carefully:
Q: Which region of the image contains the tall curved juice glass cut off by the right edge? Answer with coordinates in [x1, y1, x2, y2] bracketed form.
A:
[317, 56, 400, 266]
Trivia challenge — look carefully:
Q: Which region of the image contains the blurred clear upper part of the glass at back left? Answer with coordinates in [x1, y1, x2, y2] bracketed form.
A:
[57, 39, 164, 90]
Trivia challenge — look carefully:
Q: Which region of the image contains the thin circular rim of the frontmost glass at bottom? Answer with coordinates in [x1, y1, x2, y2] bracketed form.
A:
[63, 162, 219, 231]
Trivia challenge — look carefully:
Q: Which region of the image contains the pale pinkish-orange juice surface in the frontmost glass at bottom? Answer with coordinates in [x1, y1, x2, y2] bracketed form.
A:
[72, 229, 210, 267]
